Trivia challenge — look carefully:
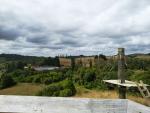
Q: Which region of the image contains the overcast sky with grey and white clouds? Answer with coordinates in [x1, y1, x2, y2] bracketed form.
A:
[0, 0, 150, 56]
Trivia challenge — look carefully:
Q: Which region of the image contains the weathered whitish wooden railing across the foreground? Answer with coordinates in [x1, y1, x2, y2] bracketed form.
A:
[0, 95, 150, 113]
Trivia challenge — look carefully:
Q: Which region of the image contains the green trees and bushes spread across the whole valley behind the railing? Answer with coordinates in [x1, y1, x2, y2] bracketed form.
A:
[0, 54, 150, 100]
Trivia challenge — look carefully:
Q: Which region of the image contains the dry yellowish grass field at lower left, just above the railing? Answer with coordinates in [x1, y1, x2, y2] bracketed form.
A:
[0, 83, 42, 96]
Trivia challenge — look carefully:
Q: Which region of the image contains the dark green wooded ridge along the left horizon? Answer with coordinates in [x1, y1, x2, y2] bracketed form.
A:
[0, 54, 60, 67]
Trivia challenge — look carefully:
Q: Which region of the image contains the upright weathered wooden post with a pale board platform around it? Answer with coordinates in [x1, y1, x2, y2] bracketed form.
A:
[118, 48, 126, 99]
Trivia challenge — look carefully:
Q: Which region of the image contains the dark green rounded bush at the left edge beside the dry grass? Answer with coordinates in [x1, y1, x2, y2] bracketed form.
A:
[0, 74, 16, 89]
